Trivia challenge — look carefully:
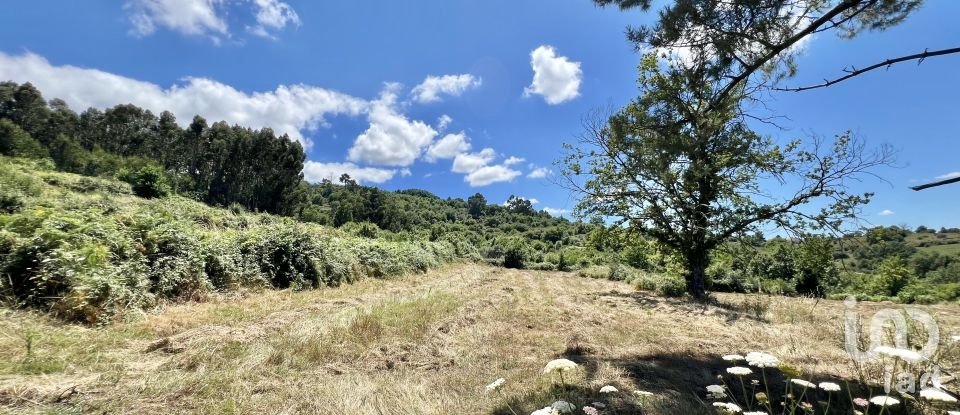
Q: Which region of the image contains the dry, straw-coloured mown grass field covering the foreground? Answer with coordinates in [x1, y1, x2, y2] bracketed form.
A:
[0, 265, 960, 414]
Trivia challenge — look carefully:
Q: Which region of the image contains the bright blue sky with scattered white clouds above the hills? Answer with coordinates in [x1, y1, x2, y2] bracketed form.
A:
[0, 0, 960, 227]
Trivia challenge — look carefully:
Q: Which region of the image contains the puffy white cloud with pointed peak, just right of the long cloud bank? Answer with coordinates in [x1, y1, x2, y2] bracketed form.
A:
[347, 84, 438, 167]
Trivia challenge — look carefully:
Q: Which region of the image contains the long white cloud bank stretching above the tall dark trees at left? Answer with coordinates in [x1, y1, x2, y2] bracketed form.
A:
[0, 52, 369, 145]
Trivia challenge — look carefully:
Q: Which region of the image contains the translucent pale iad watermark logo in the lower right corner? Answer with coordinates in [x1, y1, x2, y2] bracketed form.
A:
[844, 296, 940, 393]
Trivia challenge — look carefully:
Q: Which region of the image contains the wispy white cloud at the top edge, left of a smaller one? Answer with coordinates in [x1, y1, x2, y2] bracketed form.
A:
[123, 0, 227, 40]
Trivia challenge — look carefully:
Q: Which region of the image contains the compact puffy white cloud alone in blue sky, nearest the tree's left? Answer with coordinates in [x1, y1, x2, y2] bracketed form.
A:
[523, 45, 583, 105]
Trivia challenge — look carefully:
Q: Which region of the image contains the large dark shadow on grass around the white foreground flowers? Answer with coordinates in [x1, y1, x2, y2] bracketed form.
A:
[492, 348, 908, 415]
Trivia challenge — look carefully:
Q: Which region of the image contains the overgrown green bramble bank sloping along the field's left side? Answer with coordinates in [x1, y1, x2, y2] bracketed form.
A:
[0, 158, 457, 323]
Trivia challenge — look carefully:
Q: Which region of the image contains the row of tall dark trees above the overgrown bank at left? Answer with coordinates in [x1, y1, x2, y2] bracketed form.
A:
[0, 82, 306, 213]
